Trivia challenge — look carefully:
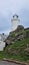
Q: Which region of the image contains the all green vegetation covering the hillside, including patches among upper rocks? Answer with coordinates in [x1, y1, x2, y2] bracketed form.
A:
[0, 27, 29, 61]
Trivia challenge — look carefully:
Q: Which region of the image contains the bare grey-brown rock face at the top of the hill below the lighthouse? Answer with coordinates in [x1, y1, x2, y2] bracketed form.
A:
[5, 25, 29, 44]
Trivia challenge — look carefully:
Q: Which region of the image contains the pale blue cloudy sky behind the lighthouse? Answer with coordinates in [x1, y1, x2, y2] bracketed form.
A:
[0, 0, 29, 34]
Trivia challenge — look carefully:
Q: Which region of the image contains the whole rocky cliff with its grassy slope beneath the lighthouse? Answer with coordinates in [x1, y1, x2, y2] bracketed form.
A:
[5, 25, 29, 61]
